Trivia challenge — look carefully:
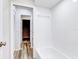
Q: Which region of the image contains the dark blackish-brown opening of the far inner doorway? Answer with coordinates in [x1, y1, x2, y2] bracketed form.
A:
[22, 19, 31, 45]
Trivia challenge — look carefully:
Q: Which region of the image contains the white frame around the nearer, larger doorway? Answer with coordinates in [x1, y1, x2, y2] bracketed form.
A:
[10, 2, 34, 59]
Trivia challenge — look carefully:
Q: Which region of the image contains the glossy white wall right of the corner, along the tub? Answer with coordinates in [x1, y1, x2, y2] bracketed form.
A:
[51, 0, 78, 59]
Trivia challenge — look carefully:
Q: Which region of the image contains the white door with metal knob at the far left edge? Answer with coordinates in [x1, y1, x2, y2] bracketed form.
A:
[0, 0, 10, 59]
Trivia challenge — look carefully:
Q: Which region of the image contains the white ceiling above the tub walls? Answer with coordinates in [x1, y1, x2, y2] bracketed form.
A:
[35, 0, 61, 8]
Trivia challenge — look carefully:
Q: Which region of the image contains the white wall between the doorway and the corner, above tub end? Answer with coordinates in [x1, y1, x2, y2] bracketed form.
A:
[33, 7, 52, 49]
